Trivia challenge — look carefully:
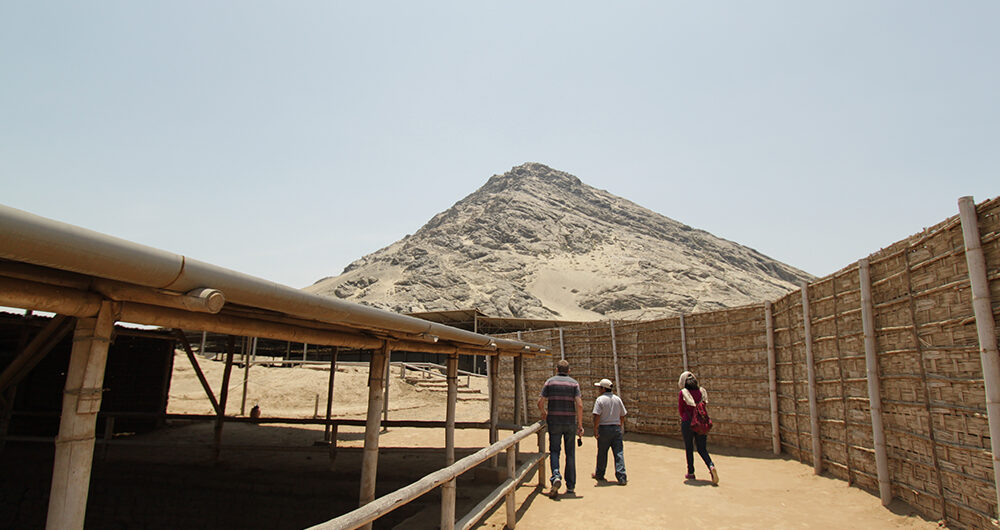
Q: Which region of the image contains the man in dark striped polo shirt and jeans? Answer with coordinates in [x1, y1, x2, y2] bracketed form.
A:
[538, 360, 583, 498]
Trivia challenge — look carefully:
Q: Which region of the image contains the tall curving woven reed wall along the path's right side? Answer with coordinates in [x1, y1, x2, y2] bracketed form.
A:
[492, 198, 1000, 528]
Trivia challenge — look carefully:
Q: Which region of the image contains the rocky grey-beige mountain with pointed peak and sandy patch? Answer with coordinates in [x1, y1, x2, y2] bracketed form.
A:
[306, 163, 812, 320]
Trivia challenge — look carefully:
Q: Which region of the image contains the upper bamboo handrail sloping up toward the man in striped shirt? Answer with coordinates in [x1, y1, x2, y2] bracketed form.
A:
[310, 421, 545, 530]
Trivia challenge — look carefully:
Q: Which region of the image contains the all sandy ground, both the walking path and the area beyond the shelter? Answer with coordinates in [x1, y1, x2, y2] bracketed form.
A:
[168, 355, 938, 529]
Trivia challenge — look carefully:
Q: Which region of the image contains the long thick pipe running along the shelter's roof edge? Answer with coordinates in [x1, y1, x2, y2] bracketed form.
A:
[0, 205, 544, 352]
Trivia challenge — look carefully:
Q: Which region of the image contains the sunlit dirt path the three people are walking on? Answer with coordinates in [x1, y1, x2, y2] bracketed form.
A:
[479, 435, 938, 529]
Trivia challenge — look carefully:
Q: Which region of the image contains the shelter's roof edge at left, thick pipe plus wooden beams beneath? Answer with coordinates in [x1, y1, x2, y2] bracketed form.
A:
[0, 205, 545, 355]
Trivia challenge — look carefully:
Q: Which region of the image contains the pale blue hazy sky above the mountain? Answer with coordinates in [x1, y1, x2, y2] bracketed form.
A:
[0, 0, 1000, 287]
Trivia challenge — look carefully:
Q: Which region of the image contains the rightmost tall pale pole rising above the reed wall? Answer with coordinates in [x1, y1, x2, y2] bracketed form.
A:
[958, 197, 1000, 516]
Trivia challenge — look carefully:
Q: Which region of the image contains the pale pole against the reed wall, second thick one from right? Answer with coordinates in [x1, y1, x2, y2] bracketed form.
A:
[858, 259, 892, 506]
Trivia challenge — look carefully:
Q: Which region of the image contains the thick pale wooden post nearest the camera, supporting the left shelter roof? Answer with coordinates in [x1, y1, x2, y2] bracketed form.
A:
[45, 301, 115, 530]
